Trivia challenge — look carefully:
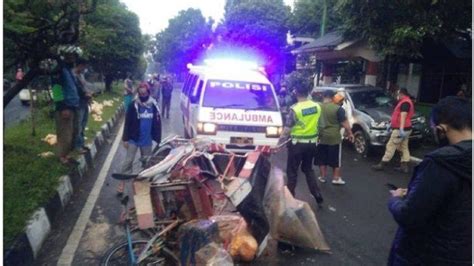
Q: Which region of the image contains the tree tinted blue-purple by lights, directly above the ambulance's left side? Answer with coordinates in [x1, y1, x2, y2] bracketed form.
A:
[154, 8, 214, 73]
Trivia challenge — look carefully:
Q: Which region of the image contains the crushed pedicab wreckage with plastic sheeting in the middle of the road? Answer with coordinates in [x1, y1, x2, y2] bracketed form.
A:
[102, 136, 329, 265]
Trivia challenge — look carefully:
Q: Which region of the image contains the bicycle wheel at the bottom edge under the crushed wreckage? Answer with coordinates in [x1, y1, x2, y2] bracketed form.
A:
[100, 240, 179, 266]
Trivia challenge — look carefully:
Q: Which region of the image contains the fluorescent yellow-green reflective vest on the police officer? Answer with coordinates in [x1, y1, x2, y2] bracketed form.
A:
[291, 100, 321, 142]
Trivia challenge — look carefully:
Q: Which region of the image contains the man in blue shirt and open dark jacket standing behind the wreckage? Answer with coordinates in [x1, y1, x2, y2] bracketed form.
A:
[117, 83, 161, 193]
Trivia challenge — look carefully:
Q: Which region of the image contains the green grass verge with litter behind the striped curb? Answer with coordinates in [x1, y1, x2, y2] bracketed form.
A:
[3, 84, 122, 247]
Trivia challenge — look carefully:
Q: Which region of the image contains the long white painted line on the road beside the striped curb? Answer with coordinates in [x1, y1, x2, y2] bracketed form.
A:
[57, 121, 123, 266]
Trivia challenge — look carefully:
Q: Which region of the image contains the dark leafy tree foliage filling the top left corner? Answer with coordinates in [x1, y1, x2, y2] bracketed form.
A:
[3, 0, 97, 108]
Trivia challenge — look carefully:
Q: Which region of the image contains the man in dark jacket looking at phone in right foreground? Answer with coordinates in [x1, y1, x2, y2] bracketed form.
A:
[388, 97, 472, 265]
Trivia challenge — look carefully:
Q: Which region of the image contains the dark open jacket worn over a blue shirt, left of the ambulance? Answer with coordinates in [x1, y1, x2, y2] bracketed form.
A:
[122, 97, 161, 143]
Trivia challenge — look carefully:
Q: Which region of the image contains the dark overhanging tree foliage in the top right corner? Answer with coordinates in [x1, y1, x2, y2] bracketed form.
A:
[337, 0, 472, 58]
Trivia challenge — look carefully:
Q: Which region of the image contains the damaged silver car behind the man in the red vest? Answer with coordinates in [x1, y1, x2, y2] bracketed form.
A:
[312, 84, 428, 155]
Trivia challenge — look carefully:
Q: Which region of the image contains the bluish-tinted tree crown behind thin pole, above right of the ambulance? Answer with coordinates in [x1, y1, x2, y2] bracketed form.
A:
[289, 0, 339, 37]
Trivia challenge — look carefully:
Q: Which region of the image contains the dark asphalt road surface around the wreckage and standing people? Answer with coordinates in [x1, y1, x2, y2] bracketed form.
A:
[37, 86, 420, 265]
